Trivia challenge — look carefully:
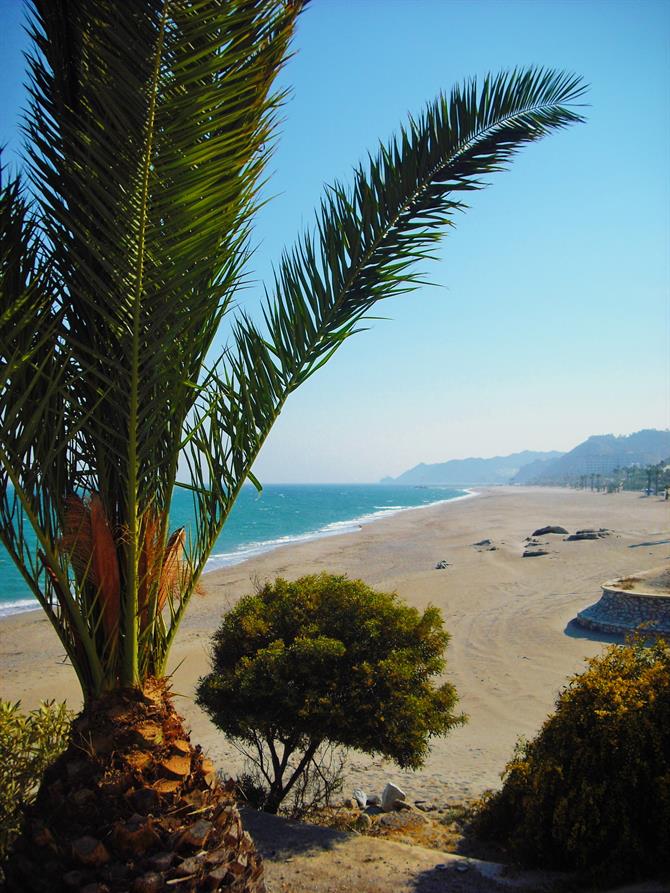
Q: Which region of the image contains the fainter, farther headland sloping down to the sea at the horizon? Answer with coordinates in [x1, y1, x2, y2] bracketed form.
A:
[382, 450, 563, 484]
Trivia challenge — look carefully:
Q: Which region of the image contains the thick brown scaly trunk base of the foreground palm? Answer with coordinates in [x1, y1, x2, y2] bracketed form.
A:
[5, 680, 265, 893]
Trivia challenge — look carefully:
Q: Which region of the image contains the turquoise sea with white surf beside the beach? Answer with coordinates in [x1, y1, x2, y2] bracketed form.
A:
[0, 484, 470, 617]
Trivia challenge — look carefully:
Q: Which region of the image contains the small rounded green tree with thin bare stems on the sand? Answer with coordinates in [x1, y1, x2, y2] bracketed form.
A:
[197, 574, 464, 812]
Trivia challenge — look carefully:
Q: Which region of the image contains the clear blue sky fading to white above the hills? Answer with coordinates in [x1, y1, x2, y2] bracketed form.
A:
[0, 0, 670, 482]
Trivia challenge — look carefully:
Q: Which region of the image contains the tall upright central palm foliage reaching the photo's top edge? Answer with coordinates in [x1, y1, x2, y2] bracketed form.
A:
[19, 0, 304, 684]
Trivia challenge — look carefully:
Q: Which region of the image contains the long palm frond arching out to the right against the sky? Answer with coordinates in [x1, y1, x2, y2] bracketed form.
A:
[178, 68, 585, 628]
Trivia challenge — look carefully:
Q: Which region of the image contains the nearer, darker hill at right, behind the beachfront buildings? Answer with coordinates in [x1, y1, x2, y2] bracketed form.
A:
[512, 428, 670, 484]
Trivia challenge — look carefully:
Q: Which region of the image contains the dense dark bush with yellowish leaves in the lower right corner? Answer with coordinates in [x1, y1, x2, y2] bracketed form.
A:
[475, 640, 670, 882]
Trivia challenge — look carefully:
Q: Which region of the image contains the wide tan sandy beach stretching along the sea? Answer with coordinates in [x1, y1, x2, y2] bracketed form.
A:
[0, 487, 670, 800]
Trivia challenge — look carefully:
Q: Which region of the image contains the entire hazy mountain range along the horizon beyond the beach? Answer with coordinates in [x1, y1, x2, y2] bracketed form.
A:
[382, 428, 670, 485]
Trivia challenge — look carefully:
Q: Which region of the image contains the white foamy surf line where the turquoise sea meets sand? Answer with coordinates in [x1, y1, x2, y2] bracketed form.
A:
[0, 484, 479, 623]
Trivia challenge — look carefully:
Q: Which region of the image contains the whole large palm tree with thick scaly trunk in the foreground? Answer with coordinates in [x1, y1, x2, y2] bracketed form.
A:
[0, 0, 583, 890]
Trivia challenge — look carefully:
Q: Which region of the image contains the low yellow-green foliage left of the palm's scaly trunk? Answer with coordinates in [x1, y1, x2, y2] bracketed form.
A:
[0, 700, 74, 858]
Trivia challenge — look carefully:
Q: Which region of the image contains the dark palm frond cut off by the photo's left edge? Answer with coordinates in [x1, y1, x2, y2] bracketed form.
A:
[0, 174, 102, 687]
